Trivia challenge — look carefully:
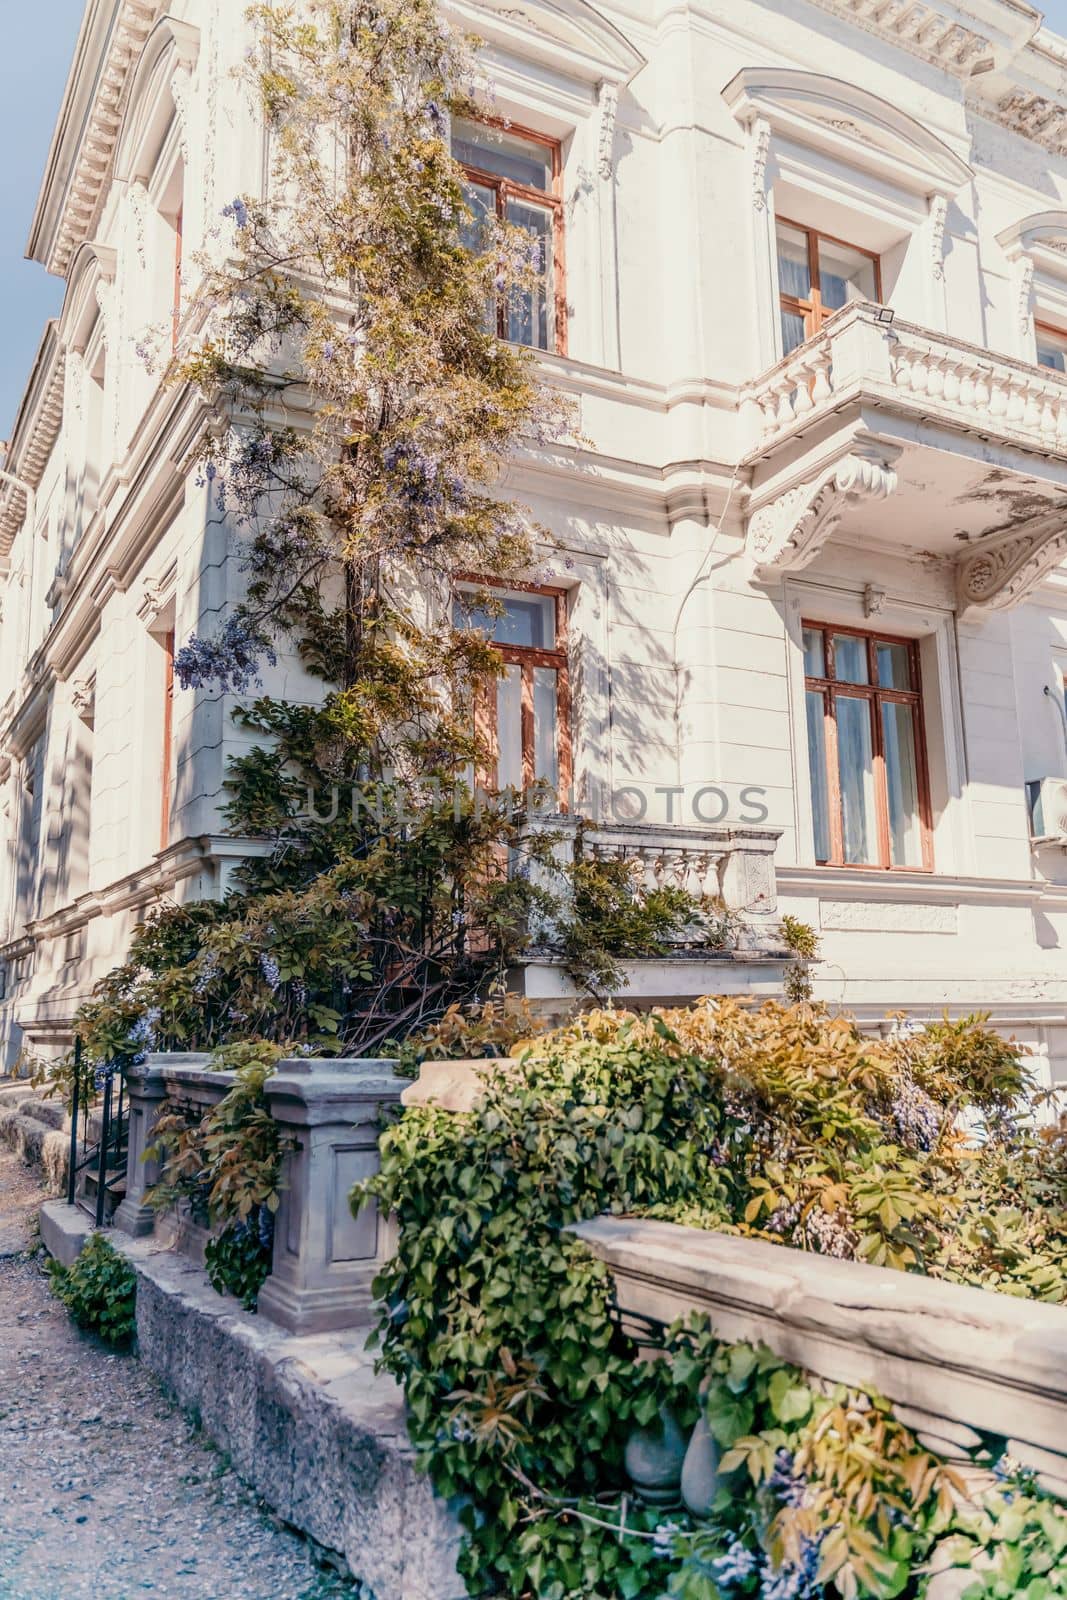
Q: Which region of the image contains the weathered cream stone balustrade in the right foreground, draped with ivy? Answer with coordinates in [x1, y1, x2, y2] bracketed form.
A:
[573, 1216, 1067, 1504]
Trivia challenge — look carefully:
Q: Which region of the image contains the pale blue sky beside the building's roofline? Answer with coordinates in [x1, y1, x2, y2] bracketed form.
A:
[0, 0, 1067, 438]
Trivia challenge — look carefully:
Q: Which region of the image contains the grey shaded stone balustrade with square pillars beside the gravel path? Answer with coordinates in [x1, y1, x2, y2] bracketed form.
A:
[115, 1054, 408, 1333]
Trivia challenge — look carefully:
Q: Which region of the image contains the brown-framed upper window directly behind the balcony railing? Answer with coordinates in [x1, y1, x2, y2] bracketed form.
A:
[777, 218, 881, 355]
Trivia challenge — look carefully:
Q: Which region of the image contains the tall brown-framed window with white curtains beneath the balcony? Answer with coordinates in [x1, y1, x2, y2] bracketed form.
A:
[803, 622, 934, 872]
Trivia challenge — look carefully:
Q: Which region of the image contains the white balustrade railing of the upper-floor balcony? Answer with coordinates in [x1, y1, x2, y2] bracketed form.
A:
[742, 302, 1067, 456]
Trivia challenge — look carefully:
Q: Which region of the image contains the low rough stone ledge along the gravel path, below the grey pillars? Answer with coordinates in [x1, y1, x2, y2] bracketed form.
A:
[109, 1232, 467, 1600]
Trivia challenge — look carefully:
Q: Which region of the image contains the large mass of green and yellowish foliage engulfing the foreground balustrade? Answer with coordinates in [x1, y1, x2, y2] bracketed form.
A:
[354, 1000, 1067, 1600]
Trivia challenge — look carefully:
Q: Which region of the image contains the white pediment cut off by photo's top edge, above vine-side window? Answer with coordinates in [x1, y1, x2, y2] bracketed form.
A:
[446, 0, 645, 85]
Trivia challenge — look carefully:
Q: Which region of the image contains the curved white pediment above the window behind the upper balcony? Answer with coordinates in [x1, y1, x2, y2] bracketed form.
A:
[723, 67, 973, 198]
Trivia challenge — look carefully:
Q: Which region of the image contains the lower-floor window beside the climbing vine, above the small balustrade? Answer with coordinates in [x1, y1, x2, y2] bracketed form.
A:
[454, 584, 571, 808]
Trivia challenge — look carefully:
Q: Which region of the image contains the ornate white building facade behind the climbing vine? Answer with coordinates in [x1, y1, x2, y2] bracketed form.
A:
[0, 0, 1067, 1080]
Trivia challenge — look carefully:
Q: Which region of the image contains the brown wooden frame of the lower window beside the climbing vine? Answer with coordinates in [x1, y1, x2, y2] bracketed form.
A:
[456, 573, 574, 811]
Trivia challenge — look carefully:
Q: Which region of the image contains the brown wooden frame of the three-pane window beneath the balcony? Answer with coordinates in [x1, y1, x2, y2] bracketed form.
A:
[800, 618, 934, 872]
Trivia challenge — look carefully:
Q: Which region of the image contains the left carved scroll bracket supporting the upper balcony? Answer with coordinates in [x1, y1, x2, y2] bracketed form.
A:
[749, 451, 897, 579]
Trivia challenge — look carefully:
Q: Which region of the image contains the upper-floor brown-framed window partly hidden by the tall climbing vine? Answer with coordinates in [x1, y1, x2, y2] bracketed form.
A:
[453, 120, 566, 355]
